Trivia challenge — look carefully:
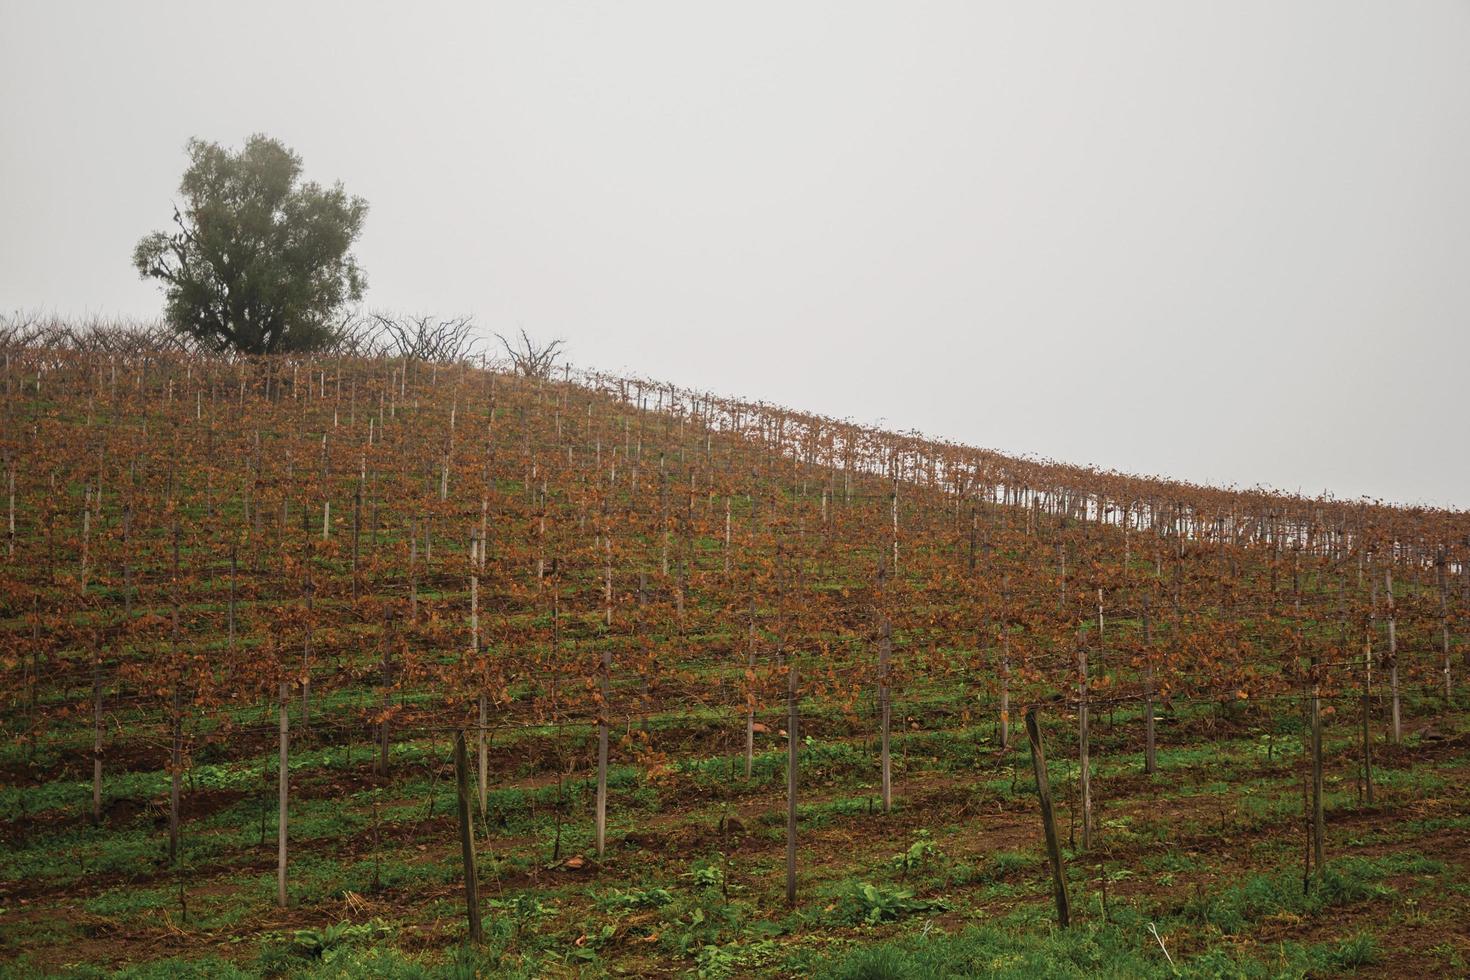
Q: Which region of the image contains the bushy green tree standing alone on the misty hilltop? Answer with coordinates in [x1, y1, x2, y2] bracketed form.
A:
[132, 134, 368, 354]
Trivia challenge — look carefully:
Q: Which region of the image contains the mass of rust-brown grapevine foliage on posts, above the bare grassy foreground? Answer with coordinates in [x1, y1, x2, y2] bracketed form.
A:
[0, 350, 1470, 922]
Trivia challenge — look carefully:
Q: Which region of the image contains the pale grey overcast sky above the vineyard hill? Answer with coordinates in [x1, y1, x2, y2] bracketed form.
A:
[0, 7, 1470, 507]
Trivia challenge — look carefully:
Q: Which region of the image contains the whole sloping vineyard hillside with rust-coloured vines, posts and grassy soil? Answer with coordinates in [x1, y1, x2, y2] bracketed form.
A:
[0, 347, 1470, 977]
